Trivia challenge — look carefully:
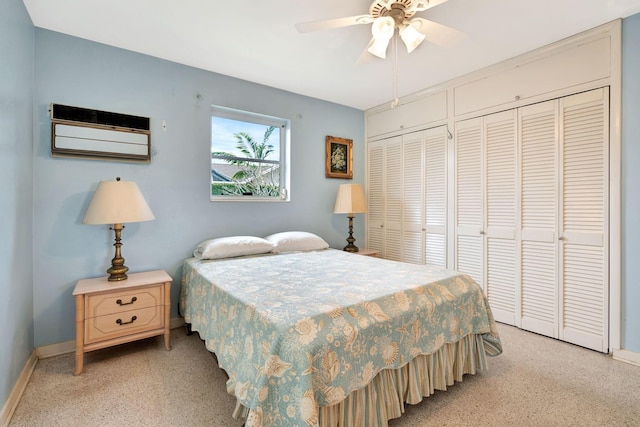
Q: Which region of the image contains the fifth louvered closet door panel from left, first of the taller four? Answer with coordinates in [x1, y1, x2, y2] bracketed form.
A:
[455, 118, 484, 288]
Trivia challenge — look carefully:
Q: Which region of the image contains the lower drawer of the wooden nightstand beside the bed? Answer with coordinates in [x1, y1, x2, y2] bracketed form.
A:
[85, 306, 164, 344]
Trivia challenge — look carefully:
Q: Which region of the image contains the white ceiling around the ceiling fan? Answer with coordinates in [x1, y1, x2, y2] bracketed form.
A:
[24, 0, 640, 110]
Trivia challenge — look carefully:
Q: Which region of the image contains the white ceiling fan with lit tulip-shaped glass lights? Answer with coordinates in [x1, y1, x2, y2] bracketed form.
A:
[296, 0, 461, 58]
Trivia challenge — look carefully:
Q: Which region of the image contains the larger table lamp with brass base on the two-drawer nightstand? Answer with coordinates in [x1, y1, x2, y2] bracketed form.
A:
[82, 177, 155, 282]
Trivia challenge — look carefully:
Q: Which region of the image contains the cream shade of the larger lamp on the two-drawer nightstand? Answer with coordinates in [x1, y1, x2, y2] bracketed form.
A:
[82, 178, 155, 224]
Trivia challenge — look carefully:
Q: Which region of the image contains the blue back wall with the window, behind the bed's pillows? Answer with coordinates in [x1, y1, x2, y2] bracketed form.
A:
[33, 29, 364, 346]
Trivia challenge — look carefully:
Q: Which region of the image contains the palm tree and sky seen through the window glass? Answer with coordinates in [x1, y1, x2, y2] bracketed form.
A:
[211, 116, 281, 197]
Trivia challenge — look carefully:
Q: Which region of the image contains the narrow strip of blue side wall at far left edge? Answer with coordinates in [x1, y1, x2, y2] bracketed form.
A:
[0, 0, 34, 412]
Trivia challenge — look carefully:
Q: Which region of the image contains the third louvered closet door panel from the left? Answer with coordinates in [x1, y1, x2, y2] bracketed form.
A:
[401, 131, 424, 264]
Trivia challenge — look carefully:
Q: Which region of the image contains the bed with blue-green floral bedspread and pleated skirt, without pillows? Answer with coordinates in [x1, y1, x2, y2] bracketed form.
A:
[180, 234, 502, 427]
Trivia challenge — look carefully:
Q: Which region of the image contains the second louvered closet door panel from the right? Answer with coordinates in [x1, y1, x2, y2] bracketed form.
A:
[519, 100, 559, 338]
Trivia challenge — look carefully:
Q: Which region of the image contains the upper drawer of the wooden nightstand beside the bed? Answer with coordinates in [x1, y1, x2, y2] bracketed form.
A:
[85, 286, 163, 318]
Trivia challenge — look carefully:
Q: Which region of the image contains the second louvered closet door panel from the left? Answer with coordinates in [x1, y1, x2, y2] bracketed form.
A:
[382, 136, 403, 261]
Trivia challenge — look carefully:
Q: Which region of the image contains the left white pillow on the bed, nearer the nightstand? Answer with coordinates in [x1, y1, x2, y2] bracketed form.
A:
[193, 236, 275, 259]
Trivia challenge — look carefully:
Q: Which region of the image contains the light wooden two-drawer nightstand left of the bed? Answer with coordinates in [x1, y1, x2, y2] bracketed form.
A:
[73, 270, 173, 375]
